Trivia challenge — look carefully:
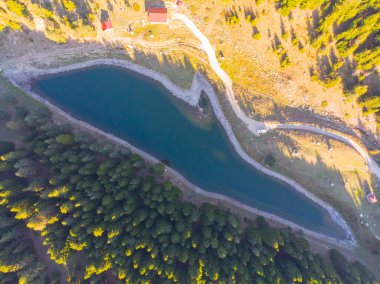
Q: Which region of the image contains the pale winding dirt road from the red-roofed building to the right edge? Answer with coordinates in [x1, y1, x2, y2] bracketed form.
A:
[172, 12, 380, 180]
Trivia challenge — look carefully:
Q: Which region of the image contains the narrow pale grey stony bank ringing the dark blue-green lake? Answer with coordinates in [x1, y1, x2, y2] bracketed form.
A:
[5, 59, 357, 248]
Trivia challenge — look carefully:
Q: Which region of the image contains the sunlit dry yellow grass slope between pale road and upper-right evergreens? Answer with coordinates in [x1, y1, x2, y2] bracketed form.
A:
[182, 0, 375, 131]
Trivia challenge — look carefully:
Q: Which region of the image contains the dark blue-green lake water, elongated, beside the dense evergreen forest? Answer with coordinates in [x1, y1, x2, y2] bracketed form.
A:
[33, 66, 344, 238]
